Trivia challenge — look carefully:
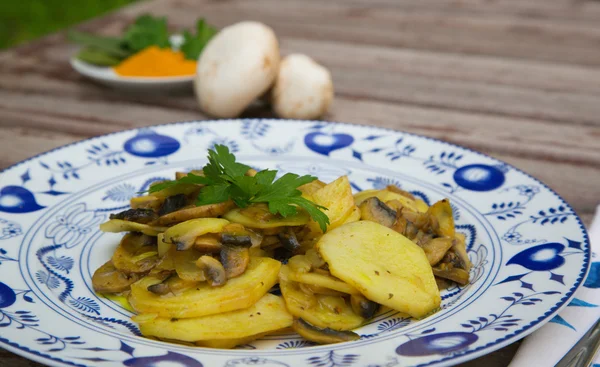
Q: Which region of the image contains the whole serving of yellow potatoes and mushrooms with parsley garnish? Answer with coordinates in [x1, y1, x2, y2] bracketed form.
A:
[92, 145, 470, 348]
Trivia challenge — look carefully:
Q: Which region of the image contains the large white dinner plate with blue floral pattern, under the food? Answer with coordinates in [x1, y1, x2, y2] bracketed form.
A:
[0, 119, 590, 367]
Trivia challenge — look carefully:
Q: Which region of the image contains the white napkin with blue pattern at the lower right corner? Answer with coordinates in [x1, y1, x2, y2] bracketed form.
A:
[509, 206, 600, 367]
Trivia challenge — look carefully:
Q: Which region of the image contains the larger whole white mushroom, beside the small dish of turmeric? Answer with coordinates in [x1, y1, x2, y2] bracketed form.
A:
[194, 22, 279, 117]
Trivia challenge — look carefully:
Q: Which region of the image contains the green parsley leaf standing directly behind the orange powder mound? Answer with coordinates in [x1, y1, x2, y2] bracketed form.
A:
[123, 14, 170, 52]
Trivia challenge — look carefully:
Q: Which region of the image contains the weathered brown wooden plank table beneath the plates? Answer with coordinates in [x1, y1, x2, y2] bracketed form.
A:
[0, 0, 600, 367]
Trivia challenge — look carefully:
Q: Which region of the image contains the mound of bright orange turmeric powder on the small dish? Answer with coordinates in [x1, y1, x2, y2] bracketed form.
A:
[113, 46, 196, 77]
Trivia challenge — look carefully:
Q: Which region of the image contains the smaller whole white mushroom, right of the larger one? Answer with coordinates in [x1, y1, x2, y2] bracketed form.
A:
[271, 54, 333, 119]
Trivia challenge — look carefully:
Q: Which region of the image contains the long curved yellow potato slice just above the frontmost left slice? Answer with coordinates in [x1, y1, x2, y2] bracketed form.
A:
[129, 257, 281, 318]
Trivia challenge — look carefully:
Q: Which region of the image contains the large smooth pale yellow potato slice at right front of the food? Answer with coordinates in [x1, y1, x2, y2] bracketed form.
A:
[313, 221, 441, 320]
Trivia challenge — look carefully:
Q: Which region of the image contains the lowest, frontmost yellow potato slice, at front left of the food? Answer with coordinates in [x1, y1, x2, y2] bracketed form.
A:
[134, 294, 294, 342]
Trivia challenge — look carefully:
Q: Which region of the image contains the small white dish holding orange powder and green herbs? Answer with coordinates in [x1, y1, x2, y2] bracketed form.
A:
[70, 35, 194, 92]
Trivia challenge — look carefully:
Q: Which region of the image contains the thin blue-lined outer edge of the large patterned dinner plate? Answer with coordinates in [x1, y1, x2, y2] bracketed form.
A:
[0, 119, 592, 367]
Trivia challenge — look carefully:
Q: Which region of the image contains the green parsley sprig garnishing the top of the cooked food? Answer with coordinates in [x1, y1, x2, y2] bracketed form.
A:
[149, 145, 329, 232]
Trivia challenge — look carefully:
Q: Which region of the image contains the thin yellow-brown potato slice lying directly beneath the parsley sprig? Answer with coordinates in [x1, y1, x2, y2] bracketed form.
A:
[223, 205, 310, 229]
